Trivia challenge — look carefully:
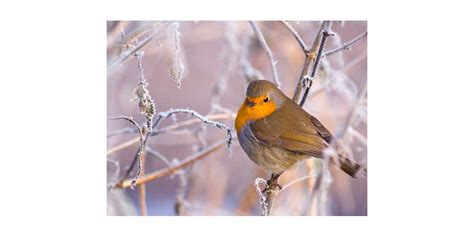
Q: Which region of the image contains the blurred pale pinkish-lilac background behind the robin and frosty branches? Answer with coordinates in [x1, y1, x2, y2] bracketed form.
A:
[107, 21, 367, 215]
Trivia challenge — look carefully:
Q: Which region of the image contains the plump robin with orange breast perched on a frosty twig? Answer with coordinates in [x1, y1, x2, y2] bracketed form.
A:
[235, 80, 360, 181]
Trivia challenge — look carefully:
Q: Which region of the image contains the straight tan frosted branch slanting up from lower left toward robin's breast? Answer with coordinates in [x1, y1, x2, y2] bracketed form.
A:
[117, 141, 225, 188]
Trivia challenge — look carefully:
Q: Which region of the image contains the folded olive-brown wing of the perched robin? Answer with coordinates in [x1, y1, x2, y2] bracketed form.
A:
[250, 101, 332, 157]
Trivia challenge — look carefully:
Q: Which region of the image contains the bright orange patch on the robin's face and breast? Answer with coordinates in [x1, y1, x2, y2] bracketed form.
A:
[235, 98, 276, 133]
